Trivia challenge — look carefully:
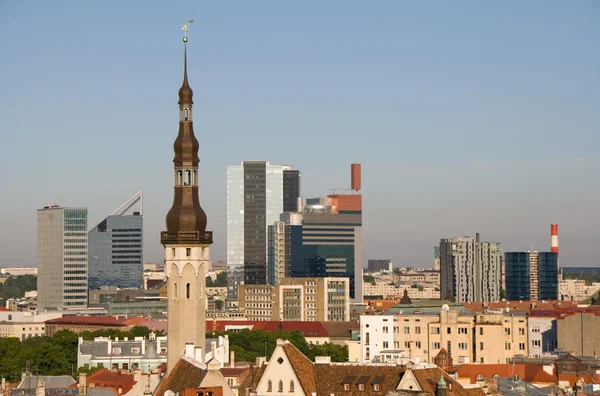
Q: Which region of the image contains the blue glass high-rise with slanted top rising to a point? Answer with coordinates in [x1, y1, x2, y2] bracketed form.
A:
[88, 190, 144, 290]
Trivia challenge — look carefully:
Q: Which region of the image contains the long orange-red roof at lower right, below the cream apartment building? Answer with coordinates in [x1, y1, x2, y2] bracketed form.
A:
[456, 364, 556, 384]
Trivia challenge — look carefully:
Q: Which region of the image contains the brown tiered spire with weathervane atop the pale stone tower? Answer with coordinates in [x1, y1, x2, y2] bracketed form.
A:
[161, 19, 212, 244]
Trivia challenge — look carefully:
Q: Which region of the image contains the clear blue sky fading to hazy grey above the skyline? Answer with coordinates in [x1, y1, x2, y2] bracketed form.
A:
[0, 0, 600, 267]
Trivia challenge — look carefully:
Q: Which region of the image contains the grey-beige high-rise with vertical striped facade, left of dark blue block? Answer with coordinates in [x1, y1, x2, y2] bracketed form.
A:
[440, 234, 502, 302]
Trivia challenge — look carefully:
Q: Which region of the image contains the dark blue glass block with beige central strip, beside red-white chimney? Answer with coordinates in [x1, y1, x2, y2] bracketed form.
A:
[504, 251, 558, 301]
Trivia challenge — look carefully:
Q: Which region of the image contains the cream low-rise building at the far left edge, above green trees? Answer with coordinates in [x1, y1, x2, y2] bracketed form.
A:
[0, 310, 62, 341]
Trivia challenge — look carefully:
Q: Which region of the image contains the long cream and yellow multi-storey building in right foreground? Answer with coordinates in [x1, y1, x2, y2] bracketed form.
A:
[358, 307, 528, 364]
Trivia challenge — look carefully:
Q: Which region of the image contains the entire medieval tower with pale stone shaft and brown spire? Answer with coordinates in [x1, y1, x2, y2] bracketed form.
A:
[160, 25, 212, 374]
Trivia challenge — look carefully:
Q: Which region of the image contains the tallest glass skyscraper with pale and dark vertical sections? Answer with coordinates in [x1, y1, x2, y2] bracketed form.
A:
[227, 161, 300, 284]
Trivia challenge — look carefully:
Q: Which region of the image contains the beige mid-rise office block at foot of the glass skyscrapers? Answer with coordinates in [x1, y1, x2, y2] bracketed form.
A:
[238, 278, 350, 322]
